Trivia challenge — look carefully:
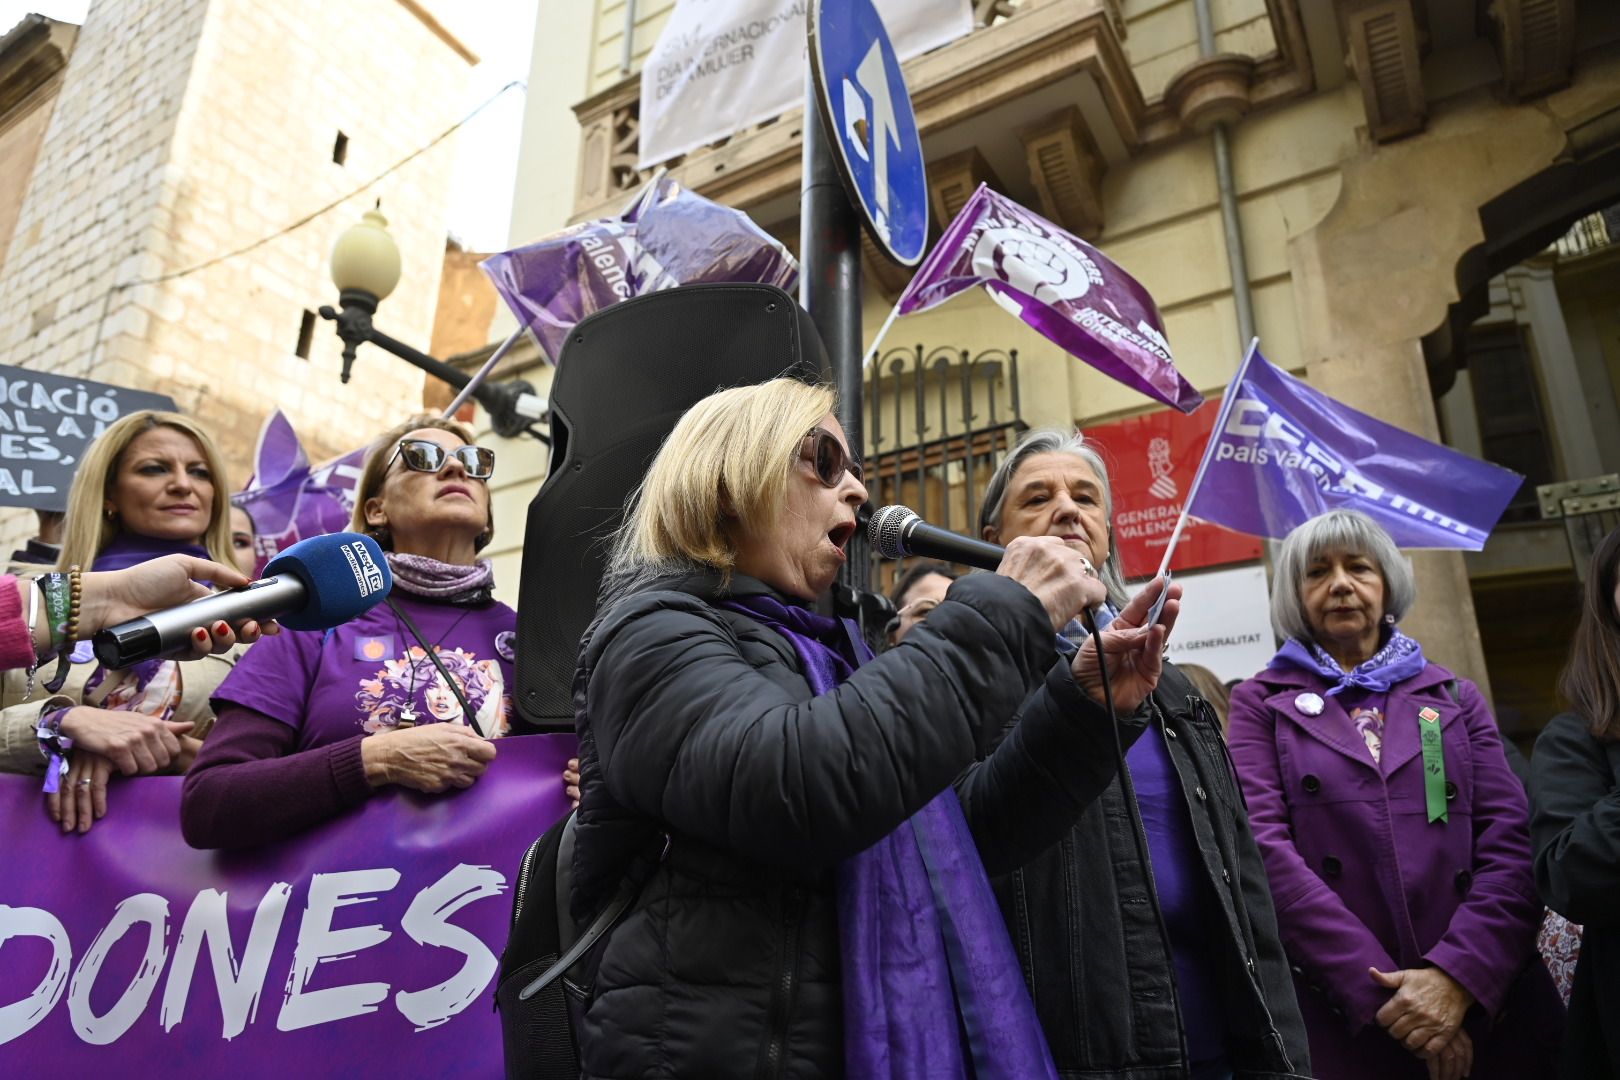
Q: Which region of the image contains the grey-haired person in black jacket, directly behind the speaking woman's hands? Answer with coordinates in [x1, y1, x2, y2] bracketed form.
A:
[965, 429, 1311, 1080]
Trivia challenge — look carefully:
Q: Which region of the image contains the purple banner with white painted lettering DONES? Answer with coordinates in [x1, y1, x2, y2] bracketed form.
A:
[0, 735, 575, 1080]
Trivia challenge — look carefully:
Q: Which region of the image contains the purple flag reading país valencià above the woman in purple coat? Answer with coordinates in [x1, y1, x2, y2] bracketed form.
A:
[1187, 353, 1524, 551]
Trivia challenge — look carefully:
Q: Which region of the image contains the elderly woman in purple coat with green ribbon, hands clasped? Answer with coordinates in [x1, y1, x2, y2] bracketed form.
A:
[1230, 510, 1563, 1080]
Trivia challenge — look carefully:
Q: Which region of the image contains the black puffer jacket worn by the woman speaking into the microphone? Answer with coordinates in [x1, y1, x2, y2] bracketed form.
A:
[573, 575, 1140, 1080]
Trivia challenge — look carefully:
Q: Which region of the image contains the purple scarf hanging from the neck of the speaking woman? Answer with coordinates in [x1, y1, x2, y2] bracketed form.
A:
[721, 596, 1058, 1080]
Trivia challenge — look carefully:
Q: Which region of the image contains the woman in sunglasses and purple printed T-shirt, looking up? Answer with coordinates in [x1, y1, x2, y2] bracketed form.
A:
[180, 416, 517, 847]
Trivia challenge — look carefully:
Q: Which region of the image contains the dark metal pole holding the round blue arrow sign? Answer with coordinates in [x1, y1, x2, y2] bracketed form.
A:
[799, 65, 870, 589]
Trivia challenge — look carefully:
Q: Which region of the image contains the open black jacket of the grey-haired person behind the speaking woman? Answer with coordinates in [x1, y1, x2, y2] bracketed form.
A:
[993, 664, 1311, 1080]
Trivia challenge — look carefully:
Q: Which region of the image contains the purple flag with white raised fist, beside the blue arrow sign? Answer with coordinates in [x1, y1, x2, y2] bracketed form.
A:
[896, 185, 1204, 413]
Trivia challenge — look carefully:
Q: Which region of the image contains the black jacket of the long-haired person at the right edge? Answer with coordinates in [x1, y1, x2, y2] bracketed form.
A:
[1529, 712, 1620, 1080]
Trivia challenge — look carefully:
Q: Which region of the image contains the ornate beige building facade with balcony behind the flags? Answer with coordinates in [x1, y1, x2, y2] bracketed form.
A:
[473, 0, 1620, 735]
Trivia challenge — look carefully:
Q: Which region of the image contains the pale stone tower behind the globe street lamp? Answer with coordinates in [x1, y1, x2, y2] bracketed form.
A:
[0, 0, 476, 539]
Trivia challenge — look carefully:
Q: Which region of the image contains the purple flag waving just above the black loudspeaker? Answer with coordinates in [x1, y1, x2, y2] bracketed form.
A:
[481, 173, 799, 361]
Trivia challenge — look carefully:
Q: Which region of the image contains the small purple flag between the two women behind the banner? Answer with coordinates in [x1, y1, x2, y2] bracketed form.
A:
[232, 410, 366, 568]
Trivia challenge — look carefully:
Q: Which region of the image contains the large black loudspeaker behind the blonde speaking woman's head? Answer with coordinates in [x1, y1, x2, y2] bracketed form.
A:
[515, 285, 831, 732]
